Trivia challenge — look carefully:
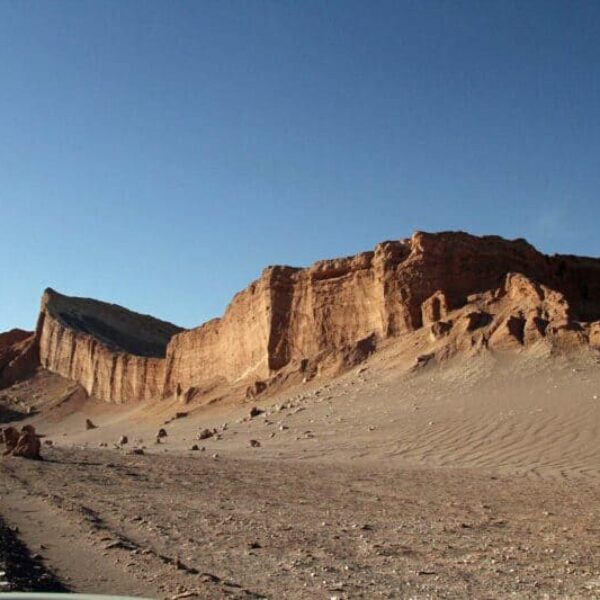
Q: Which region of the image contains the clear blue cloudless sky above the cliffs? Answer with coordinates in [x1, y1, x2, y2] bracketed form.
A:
[0, 0, 600, 331]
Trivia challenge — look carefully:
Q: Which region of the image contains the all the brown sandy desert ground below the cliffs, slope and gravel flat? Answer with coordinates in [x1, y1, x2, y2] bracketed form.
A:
[0, 349, 600, 599]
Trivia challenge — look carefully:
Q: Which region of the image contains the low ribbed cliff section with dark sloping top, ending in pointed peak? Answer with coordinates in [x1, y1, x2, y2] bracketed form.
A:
[36, 289, 181, 403]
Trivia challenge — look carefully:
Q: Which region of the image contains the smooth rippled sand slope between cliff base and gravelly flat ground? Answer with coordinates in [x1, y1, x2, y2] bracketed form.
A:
[15, 346, 600, 479]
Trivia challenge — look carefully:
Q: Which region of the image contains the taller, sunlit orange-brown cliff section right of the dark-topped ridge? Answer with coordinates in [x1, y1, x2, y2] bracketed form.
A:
[165, 233, 600, 394]
